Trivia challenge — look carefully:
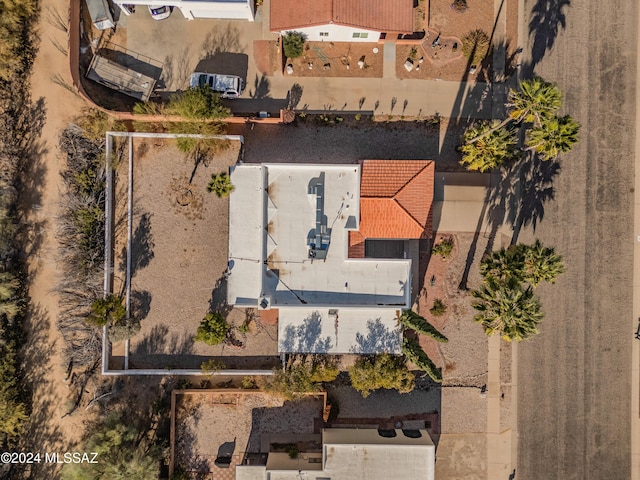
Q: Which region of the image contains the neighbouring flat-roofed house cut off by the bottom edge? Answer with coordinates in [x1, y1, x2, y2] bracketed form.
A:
[236, 428, 435, 480]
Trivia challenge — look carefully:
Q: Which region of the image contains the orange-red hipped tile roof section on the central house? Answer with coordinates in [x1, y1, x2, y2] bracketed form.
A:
[359, 160, 435, 238]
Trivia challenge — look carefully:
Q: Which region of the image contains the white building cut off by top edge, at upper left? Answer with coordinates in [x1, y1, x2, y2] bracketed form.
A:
[112, 0, 254, 22]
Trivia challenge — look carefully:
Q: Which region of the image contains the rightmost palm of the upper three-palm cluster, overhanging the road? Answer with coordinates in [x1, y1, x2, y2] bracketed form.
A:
[526, 115, 580, 160]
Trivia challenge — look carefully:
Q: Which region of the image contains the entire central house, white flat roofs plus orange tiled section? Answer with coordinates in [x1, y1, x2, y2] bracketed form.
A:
[227, 160, 433, 354]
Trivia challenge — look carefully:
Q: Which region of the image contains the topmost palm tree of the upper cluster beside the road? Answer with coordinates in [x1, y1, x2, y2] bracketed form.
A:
[507, 77, 562, 125]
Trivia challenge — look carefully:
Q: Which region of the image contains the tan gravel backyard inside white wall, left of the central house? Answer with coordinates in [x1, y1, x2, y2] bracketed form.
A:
[113, 138, 277, 369]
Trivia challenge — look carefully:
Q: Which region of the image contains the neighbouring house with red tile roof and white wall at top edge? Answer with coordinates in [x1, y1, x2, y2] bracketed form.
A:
[270, 0, 413, 42]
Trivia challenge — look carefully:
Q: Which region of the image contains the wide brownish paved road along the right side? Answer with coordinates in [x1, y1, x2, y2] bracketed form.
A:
[516, 0, 637, 480]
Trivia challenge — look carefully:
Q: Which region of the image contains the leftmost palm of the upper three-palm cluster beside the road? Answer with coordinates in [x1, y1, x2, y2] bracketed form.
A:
[460, 121, 518, 172]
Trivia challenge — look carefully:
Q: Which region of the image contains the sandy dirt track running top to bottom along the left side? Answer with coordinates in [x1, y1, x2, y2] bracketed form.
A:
[18, 0, 92, 478]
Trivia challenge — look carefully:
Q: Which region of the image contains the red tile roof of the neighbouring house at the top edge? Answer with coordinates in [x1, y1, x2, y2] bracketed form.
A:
[270, 0, 413, 33]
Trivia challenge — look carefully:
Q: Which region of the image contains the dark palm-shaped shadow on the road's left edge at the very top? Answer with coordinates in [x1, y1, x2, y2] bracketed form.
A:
[524, 0, 571, 77]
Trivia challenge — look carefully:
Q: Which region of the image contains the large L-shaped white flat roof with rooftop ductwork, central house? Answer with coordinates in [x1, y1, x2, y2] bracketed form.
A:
[228, 164, 411, 308]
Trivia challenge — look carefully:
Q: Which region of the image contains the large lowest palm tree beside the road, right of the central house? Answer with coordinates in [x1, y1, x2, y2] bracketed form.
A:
[471, 277, 544, 342]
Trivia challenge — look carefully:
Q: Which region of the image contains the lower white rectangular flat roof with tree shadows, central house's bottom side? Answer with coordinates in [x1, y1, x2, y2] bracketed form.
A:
[278, 307, 402, 354]
